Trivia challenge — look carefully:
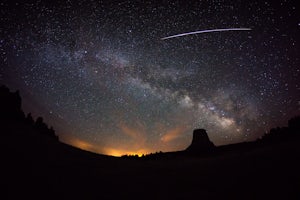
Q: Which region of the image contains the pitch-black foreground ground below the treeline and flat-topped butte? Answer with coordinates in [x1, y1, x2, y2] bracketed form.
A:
[1, 119, 300, 199]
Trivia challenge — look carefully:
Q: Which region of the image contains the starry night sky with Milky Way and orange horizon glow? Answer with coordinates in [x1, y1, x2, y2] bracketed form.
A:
[0, 0, 300, 156]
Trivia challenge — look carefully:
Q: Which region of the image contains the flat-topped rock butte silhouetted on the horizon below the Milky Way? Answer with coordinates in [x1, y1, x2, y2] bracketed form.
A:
[186, 129, 215, 154]
